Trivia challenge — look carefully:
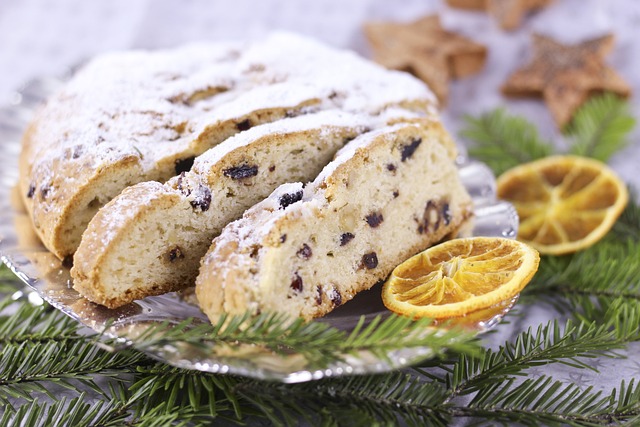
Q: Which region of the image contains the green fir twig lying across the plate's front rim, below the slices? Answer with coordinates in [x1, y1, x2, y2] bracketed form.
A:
[134, 313, 479, 369]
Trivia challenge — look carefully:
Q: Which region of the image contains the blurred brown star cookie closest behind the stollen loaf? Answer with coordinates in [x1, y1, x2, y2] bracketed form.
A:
[364, 15, 487, 104]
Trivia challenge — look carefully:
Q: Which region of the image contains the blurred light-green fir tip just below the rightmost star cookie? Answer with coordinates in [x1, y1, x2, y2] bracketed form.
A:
[565, 93, 636, 163]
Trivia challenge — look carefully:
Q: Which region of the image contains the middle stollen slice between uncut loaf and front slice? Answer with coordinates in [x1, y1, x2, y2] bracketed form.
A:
[71, 110, 412, 308]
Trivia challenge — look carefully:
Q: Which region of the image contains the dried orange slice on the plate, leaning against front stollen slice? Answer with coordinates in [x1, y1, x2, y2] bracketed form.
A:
[382, 237, 540, 319]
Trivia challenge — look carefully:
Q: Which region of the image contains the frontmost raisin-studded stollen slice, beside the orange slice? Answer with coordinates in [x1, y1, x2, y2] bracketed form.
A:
[196, 121, 471, 322]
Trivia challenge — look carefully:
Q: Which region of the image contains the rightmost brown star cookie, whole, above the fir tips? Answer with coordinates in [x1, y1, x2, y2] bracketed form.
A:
[502, 34, 631, 128]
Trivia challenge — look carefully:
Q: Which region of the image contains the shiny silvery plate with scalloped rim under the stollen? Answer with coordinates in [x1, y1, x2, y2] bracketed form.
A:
[0, 79, 518, 383]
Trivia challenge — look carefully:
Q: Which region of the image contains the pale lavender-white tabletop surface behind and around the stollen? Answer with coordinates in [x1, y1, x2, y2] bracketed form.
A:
[0, 0, 640, 402]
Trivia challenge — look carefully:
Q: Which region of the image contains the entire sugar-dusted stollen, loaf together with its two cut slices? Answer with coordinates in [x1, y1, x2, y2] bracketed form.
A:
[20, 33, 480, 319]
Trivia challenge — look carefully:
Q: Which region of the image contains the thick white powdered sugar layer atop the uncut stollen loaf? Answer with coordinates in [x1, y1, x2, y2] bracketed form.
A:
[28, 33, 435, 176]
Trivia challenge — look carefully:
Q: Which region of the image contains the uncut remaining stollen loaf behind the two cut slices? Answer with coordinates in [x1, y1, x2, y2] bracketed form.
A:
[20, 33, 434, 258]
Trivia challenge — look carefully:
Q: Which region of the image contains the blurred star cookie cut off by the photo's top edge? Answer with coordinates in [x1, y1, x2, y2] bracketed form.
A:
[447, 0, 553, 30]
